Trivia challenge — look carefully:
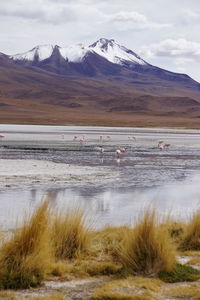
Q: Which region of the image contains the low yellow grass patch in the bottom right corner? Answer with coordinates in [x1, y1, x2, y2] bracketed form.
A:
[167, 285, 200, 300]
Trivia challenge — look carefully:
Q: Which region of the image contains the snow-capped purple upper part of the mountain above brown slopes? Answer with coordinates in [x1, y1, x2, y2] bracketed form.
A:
[9, 38, 199, 89]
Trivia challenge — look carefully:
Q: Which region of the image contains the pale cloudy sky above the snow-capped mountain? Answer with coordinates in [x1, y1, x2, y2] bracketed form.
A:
[0, 0, 200, 82]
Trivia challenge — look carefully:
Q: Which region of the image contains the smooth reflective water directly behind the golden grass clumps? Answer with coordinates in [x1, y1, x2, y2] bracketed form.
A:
[0, 175, 200, 228]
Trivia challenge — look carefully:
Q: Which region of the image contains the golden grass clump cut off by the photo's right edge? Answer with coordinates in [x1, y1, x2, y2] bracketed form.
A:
[179, 210, 200, 251]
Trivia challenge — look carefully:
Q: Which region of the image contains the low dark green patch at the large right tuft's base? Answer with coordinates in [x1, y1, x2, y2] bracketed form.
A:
[158, 264, 200, 283]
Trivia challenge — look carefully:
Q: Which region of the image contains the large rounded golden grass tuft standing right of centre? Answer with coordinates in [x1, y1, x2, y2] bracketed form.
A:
[118, 212, 176, 276]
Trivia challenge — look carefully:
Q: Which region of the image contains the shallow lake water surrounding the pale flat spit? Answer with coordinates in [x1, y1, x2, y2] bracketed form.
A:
[0, 125, 200, 228]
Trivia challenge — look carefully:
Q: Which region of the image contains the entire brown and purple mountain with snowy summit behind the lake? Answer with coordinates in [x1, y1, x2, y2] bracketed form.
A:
[0, 39, 200, 127]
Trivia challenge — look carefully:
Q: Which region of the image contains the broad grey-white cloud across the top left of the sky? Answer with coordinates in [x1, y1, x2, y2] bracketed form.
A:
[0, 0, 170, 30]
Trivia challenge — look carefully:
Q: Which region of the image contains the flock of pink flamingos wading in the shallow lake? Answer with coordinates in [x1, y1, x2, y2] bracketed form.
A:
[0, 134, 171, 158]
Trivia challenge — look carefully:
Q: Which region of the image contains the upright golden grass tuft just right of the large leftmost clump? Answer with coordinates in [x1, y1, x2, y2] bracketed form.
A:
[52, 209, 90, 259]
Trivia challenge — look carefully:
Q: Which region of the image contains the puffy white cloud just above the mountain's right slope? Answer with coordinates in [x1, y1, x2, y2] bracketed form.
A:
[139, 38, 200, 60]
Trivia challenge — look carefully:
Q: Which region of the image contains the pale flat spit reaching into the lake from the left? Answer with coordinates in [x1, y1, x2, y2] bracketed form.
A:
[0, 159, 118, 187]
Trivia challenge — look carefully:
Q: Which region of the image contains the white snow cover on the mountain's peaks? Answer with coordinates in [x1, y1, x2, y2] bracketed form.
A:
[10, 38, 147, 65]
